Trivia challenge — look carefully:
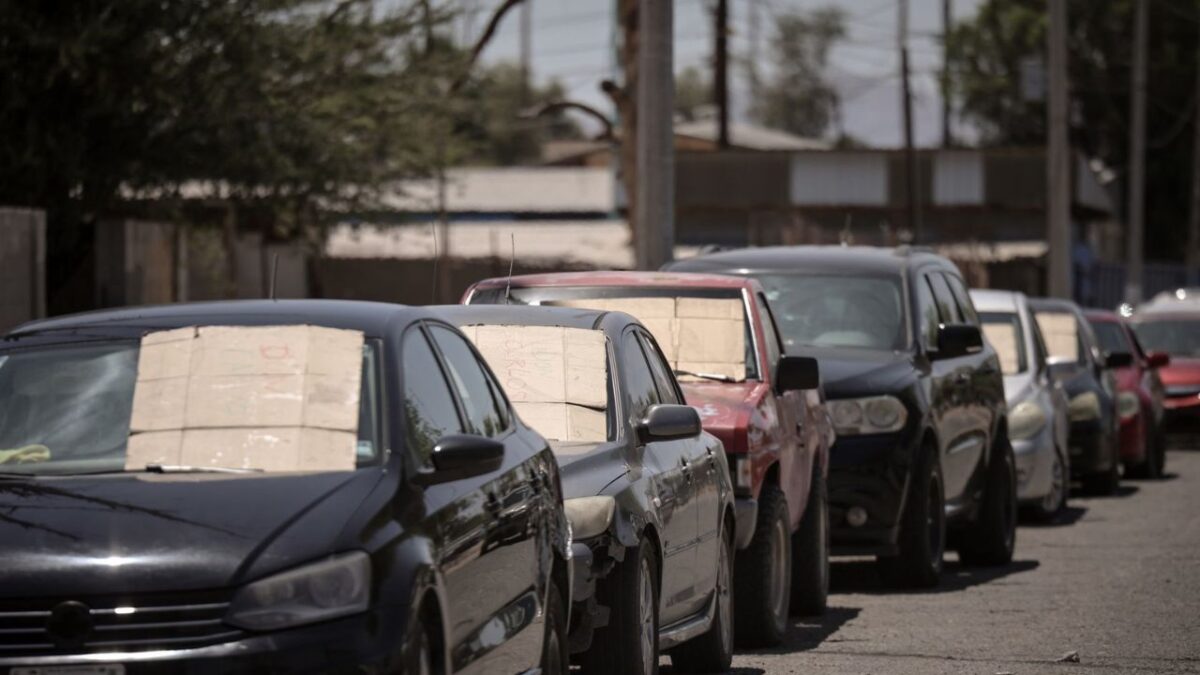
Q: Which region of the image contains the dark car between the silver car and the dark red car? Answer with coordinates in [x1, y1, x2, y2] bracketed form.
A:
[1030, 298, 1130, 495]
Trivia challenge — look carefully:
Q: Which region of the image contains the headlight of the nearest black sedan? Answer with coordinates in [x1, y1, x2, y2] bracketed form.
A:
[226, 551, 371, 631]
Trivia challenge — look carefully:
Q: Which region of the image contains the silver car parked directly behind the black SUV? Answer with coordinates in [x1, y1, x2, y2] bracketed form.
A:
[971, 291, 1070, 521]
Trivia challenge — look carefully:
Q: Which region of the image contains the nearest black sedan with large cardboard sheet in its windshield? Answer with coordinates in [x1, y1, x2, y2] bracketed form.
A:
[0, 300, 571, 675]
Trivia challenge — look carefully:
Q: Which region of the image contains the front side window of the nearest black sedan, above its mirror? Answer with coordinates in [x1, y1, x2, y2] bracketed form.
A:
[401, 328, 463, 466]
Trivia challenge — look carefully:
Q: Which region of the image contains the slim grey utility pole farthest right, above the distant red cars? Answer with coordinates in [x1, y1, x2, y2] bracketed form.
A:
[1126, 0, 1150, 305]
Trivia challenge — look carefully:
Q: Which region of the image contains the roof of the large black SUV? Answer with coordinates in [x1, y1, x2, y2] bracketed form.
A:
[667, 246, 956, 274]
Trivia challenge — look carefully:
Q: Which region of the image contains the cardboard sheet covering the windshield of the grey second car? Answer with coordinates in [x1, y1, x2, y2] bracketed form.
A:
[462, 325, 608, 443]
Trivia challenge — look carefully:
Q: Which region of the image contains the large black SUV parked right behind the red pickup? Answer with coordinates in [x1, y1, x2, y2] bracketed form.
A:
[670, 246, 1016, 586]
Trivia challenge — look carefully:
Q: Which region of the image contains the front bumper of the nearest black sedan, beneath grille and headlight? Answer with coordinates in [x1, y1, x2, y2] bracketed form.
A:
[0, 607, 407, 675]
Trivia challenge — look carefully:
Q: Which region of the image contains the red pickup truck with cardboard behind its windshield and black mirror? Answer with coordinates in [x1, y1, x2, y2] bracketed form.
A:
[463, 271, 834, 646]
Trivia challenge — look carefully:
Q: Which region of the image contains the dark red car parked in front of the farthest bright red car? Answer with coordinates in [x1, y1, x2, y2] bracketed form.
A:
[1084, 310, 1170, 478]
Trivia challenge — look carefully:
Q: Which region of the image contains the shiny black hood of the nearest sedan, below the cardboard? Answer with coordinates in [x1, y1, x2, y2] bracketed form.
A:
[0, 470, 382, 598]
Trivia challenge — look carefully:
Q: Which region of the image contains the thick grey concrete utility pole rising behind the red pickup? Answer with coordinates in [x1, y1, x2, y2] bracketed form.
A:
[635, 0, 674, 269]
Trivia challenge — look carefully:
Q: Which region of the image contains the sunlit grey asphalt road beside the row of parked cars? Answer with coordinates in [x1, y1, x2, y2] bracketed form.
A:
[681, 452, 1200, 675]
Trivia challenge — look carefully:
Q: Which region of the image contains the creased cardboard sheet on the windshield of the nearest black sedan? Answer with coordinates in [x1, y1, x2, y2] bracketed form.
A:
[125, 325, 362, 471]
